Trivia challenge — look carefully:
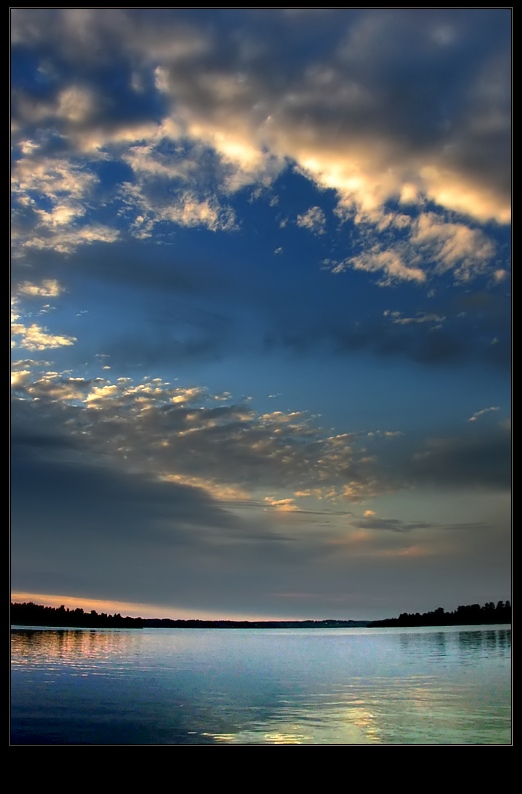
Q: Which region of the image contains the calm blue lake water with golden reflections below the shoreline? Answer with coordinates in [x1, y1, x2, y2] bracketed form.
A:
[11, 626, 511, 745]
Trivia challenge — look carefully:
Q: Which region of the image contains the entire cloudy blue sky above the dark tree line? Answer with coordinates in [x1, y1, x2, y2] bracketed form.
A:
[11, 8, 511, 620]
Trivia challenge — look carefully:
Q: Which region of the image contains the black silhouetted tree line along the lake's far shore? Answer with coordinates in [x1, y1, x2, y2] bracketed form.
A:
[11, 601, 511, 629]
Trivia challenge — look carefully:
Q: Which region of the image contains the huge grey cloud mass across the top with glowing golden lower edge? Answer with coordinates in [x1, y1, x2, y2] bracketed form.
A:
[12, 9, 511, 262]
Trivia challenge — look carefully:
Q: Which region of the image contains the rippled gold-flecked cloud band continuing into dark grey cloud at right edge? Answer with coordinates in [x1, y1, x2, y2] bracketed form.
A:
[13, 360, 511, 498]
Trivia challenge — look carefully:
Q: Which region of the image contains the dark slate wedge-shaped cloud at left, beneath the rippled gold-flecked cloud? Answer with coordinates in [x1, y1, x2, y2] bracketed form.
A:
[12, 437, 236, 547]
